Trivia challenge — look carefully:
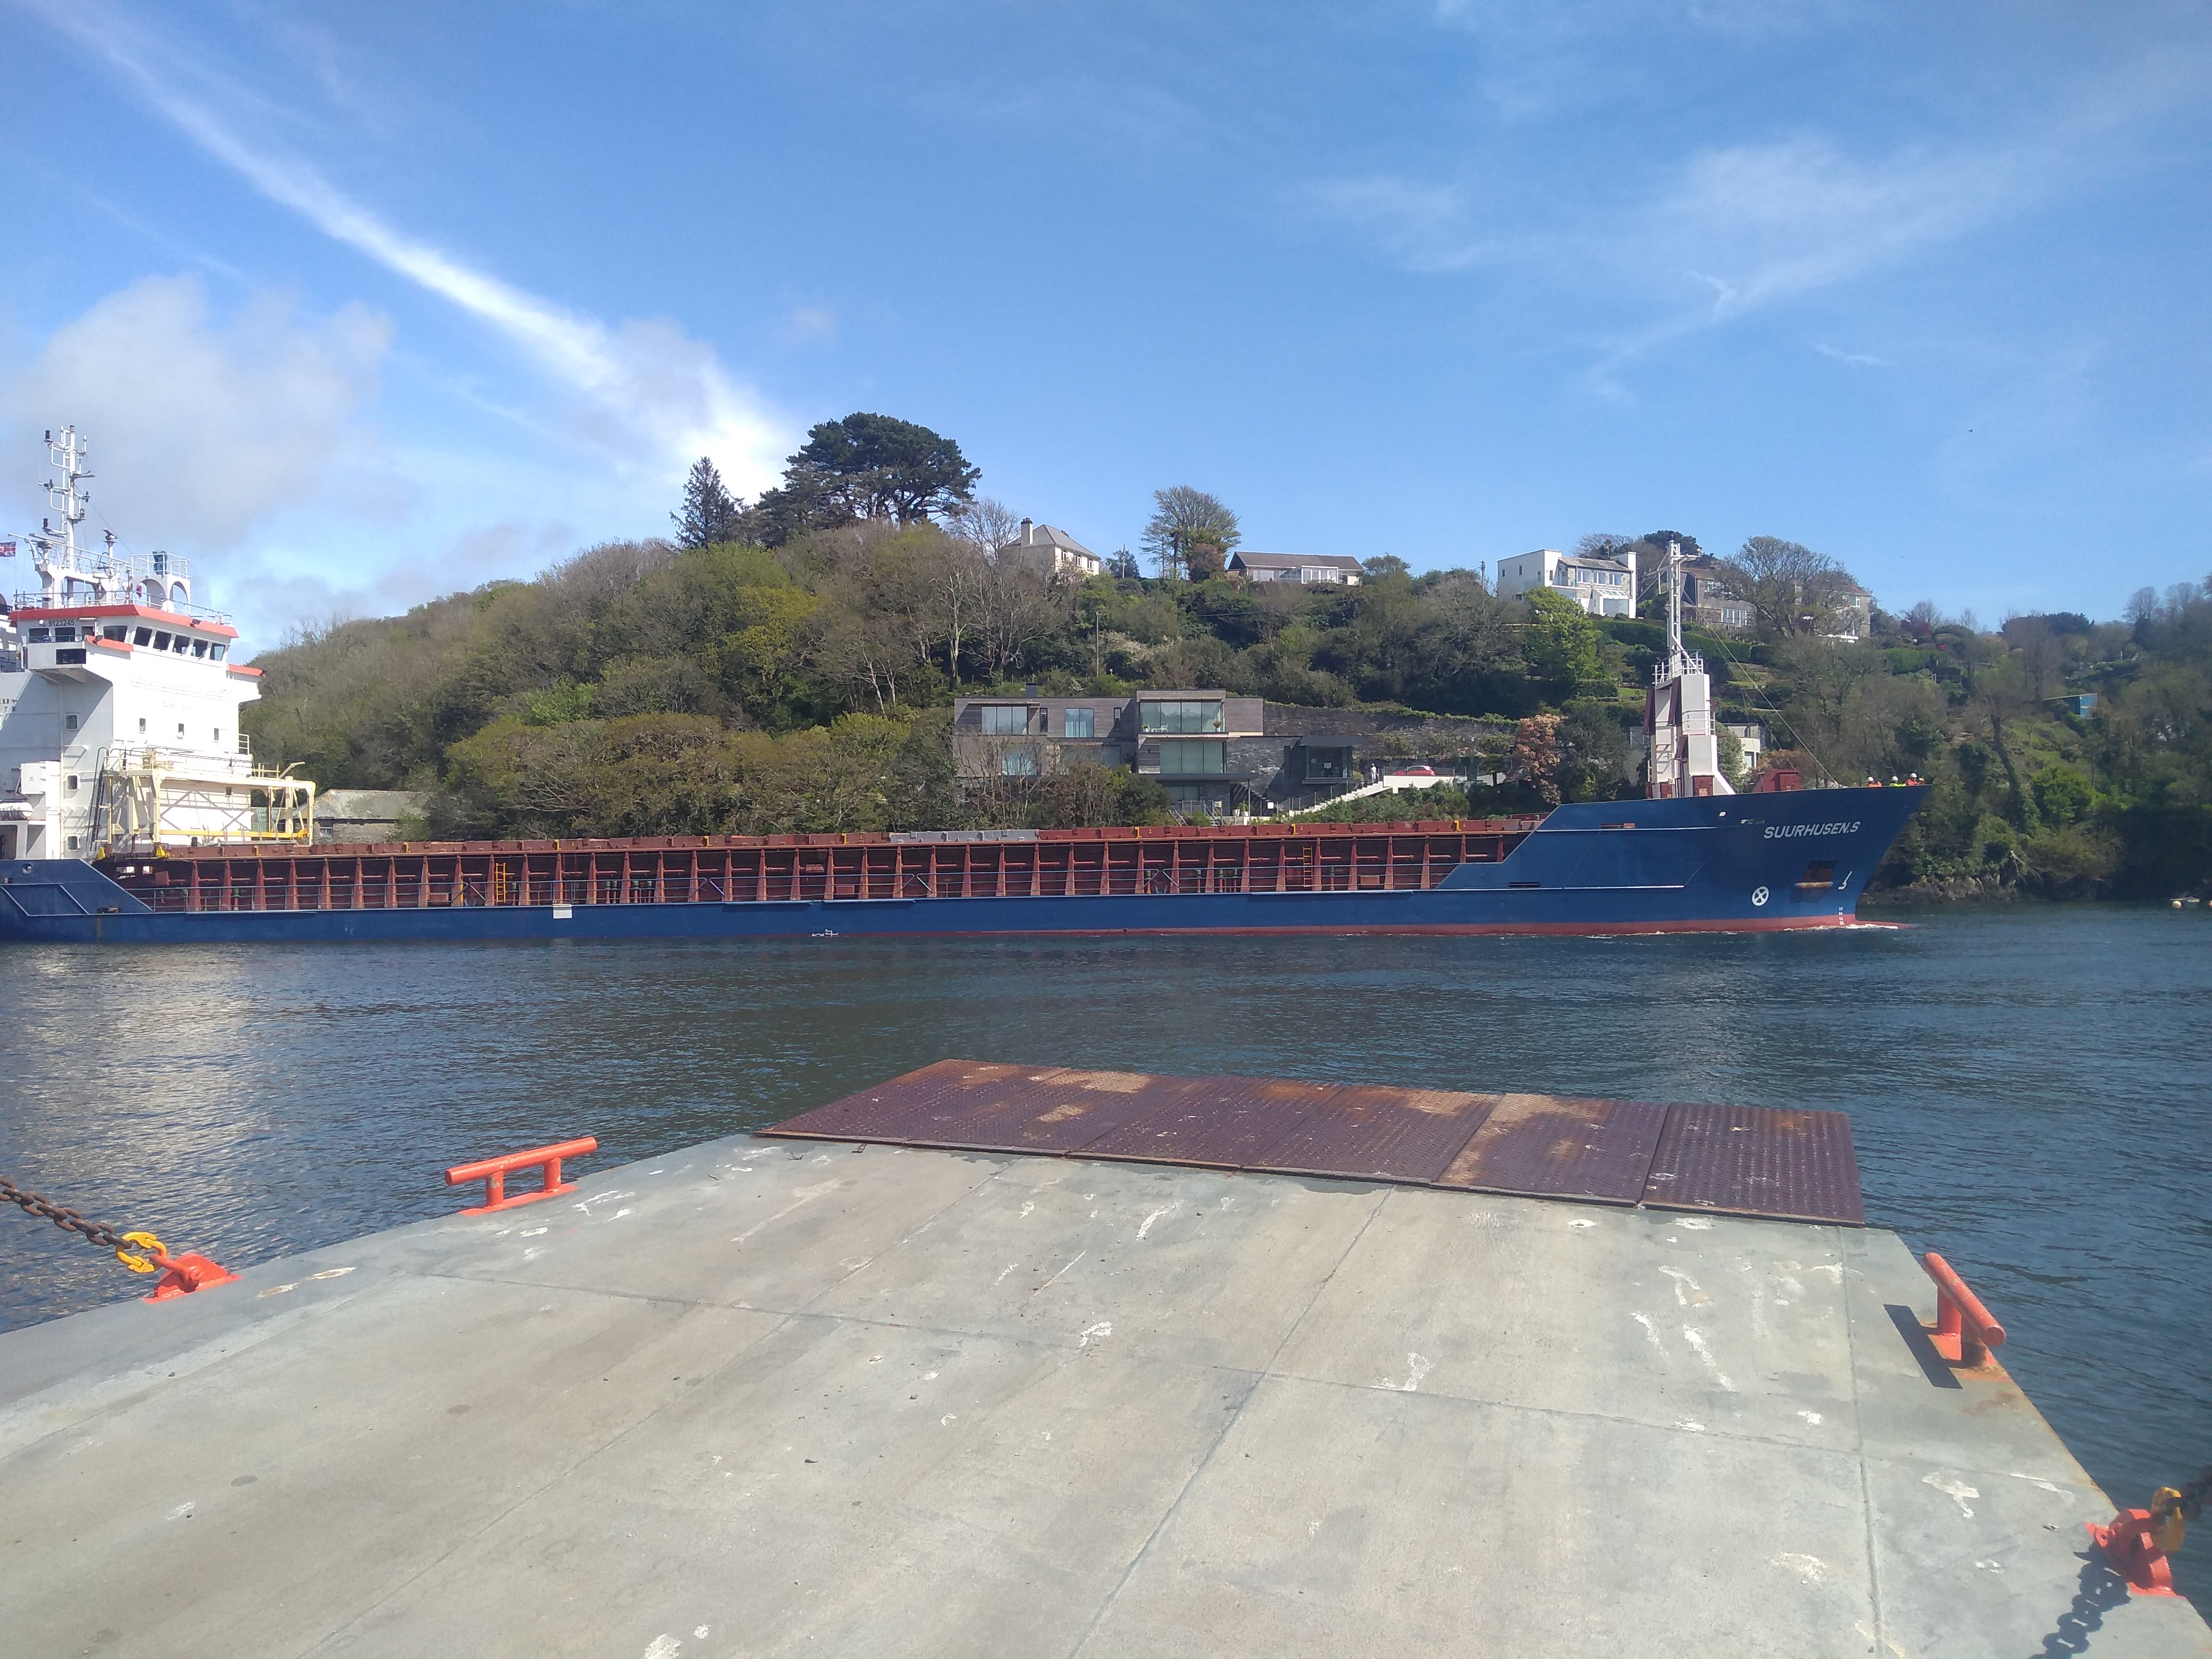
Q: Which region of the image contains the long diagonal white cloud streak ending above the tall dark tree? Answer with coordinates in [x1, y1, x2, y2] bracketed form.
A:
[46, 9, 785, 491]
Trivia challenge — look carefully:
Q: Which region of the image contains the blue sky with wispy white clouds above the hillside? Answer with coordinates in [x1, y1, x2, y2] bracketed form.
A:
[0, 0, 2212, 644]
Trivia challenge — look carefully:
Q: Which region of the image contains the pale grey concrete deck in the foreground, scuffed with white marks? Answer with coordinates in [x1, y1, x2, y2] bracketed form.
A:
[0, 1070, 2212, 1659]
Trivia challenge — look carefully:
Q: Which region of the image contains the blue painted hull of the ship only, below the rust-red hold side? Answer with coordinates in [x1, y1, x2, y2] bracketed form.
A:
[0, 787, 1922, 944]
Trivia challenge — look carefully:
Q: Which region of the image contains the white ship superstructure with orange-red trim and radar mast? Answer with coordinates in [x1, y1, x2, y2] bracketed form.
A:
[0, 427, 314, 860]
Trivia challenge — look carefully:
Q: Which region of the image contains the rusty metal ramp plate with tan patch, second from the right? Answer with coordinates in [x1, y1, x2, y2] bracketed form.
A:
[1436, 1095, 1665, 1203]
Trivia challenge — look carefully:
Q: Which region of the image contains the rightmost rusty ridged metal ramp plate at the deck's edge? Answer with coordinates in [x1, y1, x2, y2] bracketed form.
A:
[1644, 1106, 1867, 1228]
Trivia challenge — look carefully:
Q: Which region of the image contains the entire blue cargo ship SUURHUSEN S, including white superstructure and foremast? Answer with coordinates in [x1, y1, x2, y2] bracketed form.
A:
[0, 449, 1920, 944]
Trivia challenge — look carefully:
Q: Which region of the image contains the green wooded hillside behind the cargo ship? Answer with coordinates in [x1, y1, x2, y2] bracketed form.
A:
[233, 416, 2212, 896]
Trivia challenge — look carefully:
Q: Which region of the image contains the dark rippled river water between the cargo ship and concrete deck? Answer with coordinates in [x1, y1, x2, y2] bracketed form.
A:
[0, 907, 2212, 1608]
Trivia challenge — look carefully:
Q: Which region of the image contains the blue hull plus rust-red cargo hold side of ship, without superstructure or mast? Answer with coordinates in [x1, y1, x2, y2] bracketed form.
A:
[0, 785, 1922, 944]
